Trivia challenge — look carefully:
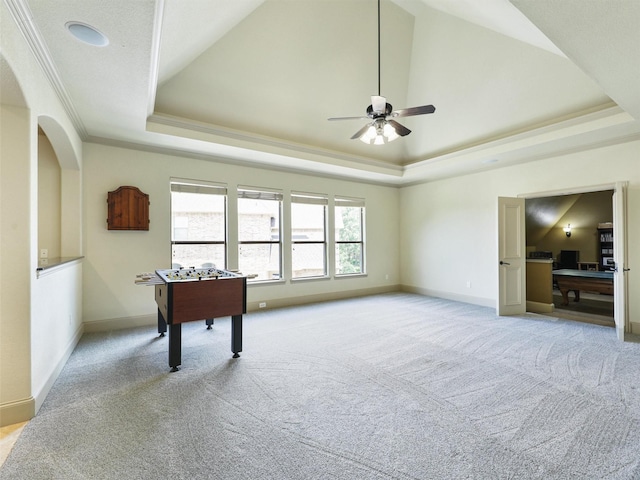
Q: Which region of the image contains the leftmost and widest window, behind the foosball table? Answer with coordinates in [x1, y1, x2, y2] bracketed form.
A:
[171, 181, 227, 268]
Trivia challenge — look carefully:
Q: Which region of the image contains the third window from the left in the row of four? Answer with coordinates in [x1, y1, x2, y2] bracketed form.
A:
[291, 193, 329, 278]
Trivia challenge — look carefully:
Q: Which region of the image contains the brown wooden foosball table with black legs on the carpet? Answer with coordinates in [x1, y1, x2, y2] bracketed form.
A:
[136, 268, 247, 372]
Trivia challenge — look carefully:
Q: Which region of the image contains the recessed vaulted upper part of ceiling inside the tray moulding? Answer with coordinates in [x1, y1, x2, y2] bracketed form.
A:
[155, 0, 609, 165]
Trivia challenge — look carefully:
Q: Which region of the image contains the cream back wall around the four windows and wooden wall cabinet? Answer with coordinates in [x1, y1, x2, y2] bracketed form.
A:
[83, 144, 399, 328]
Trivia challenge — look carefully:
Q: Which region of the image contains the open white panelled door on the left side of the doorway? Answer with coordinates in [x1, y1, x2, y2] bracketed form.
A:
[497, 197, 527, 315]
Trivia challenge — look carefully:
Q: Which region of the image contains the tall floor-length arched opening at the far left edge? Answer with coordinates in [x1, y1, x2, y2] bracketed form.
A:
[0, 55, 35, 426]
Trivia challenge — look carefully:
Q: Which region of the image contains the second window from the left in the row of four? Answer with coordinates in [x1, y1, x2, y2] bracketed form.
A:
[238, 188, 282, 281]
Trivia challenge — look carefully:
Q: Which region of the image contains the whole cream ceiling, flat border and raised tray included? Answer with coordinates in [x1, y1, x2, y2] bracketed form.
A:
[15, 0, 640, 185]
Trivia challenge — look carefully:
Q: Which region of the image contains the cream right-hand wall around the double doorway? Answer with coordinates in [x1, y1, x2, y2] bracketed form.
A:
[400, 141, 640, 333]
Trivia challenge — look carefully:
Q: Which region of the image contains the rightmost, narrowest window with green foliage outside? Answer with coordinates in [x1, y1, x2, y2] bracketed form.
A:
[335, 197, 365, 275]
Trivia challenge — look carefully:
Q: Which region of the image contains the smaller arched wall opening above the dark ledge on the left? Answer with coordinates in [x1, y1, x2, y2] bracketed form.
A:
[38, 128, 62, 263]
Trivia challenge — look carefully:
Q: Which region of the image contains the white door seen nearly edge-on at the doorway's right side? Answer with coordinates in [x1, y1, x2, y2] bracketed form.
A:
[613, 182, 629, 340]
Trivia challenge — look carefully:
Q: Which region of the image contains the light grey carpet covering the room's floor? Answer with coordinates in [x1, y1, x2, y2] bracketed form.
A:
[0, 293, 640, 480]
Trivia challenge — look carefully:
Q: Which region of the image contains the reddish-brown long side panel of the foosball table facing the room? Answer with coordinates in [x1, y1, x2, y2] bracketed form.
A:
[171, 278, 246, 323]
